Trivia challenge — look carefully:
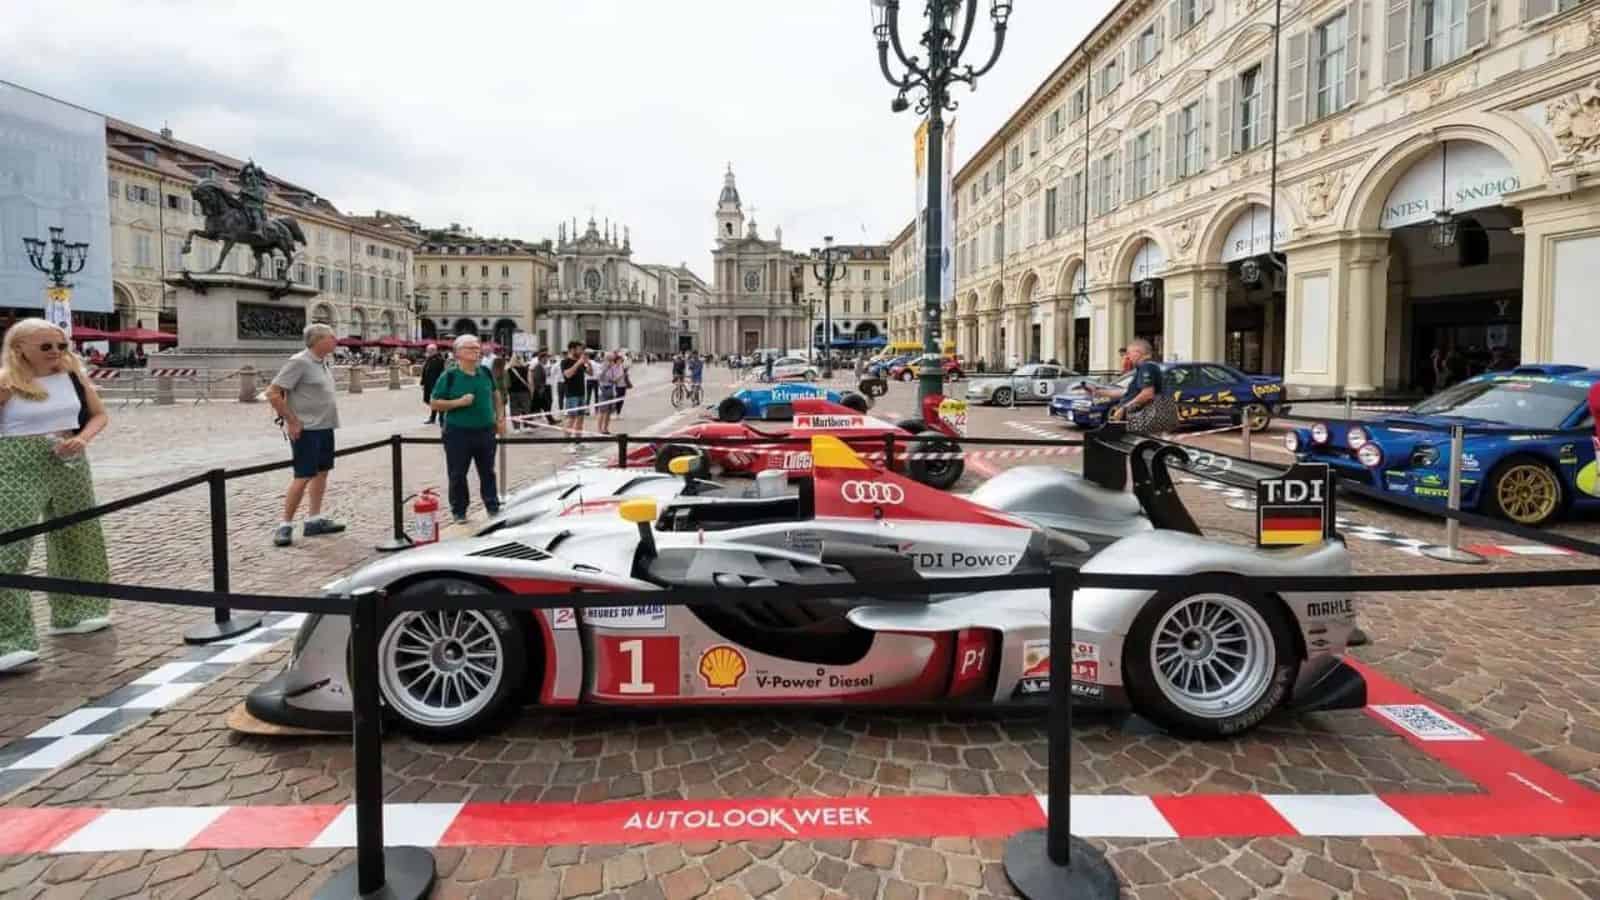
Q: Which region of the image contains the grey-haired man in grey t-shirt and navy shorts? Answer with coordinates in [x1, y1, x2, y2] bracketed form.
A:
[267, 322, 344, 546]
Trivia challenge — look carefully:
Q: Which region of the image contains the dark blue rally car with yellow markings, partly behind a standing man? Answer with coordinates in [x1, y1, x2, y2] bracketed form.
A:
[1050, 362, 1285, 431]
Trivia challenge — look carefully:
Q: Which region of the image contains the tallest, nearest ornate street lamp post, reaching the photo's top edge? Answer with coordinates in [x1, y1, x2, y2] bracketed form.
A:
[869, 0, 1011, 404]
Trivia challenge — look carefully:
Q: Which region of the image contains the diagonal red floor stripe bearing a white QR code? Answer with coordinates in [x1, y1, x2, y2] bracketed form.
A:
[1346, 657, 1597, 804]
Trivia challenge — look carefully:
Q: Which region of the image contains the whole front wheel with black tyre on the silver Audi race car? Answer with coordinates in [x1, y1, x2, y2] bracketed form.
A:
[378, 578, 534, 740]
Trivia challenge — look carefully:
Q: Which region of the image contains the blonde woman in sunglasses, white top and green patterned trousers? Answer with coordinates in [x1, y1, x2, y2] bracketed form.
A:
[0, 319, 110, 673]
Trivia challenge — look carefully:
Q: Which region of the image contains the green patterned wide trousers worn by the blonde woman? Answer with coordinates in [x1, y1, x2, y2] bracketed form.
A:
[0, 437, 110, 657]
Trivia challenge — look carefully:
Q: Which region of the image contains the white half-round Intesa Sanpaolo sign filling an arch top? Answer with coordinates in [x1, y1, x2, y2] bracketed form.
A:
[1378, 141, 1522, 229]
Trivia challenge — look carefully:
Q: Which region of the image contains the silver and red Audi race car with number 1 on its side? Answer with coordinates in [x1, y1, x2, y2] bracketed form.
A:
[246, 436, 1366, 737]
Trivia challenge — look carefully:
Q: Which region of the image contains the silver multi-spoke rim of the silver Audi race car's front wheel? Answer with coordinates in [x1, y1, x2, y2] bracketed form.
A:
[378, 610, 506, 727]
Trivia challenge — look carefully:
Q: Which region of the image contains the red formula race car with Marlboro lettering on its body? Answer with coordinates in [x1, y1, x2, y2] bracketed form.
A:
[627, 396, 966, 490]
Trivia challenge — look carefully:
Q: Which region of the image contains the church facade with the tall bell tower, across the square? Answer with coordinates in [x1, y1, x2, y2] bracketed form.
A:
[701, 167, 811, 356]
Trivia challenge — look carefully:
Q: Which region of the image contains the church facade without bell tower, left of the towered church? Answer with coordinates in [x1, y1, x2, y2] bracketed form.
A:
[536, 216, 670, 352]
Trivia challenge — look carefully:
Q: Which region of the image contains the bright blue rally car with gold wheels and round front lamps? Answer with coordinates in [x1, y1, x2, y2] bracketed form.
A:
[1285, 365, 1600, 525]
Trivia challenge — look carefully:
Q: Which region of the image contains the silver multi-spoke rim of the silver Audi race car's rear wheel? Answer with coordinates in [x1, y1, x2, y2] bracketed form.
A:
[1150, 594, 1275, 719]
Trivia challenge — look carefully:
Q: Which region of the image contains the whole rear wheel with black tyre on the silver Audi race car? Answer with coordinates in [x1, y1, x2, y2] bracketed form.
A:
[1123, 591, 1299, 740]
